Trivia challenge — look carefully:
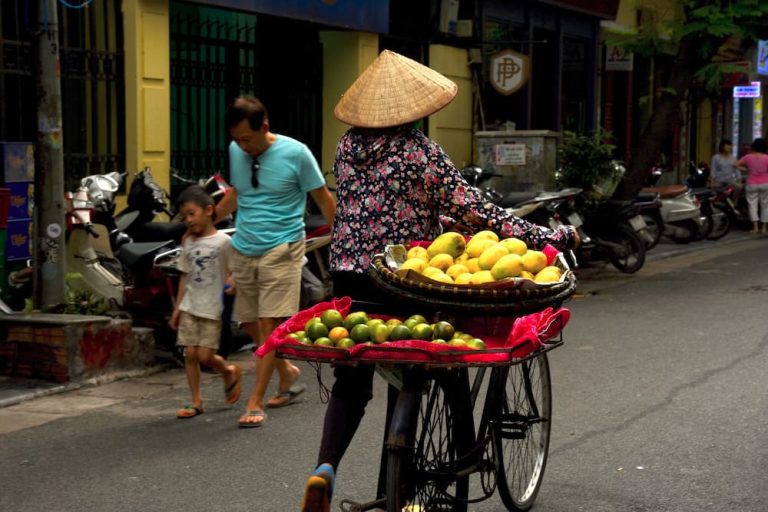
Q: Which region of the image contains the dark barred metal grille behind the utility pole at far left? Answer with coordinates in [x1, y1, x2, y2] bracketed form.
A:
[0, 0, 125, 188]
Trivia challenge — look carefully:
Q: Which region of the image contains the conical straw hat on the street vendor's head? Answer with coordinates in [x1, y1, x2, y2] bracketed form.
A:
[333, 50, 458, 128]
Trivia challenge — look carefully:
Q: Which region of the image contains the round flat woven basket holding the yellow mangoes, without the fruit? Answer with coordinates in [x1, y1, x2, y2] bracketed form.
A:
[370, 255, 576, 313]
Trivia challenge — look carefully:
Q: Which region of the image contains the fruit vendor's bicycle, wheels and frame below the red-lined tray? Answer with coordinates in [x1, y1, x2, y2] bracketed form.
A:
[341, 338, 562, 512]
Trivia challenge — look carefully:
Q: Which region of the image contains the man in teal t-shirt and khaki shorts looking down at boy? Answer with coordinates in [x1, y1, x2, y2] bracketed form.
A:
[216, 96, 336, 427]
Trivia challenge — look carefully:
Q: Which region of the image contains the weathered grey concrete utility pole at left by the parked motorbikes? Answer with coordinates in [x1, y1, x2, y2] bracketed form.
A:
[33, 0, 66, 309]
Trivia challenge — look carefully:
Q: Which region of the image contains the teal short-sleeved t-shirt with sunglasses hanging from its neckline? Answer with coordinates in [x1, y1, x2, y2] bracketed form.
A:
[229, 135, 325, 256]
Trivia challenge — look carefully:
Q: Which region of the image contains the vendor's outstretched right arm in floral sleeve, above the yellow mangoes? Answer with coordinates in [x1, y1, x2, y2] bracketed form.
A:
[424, 145, 579, 249]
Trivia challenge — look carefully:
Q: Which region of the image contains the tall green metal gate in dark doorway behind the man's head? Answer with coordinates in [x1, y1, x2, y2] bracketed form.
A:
[170, 1, 322, 191]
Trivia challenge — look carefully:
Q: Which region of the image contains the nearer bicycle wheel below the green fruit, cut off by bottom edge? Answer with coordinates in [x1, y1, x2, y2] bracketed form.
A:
[387, 370, 474, 512]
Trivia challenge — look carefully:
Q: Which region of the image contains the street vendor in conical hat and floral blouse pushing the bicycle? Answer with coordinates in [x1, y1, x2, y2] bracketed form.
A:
[302, 50, 579, 512]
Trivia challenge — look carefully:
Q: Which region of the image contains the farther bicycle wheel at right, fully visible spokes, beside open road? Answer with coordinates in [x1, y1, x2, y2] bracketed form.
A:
[491, 354, 552, 511]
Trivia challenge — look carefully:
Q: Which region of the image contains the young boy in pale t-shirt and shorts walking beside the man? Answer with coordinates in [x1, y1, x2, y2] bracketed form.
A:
[170, 185, 242, 419]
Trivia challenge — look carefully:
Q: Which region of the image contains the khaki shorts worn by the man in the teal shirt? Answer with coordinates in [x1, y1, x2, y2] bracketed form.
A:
[231, 240, 304, 322]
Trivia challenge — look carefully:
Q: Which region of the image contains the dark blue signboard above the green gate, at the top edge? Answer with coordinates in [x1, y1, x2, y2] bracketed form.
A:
[187, 0, 389, 34]
